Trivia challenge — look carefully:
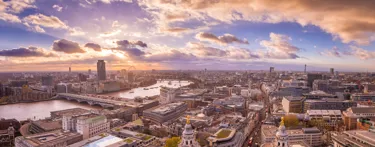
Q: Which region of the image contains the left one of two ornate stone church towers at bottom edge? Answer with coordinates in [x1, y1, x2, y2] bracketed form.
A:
[178, 116, 200, 147]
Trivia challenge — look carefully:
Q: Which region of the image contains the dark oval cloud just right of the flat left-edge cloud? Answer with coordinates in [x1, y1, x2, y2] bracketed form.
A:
[52, 39, 86, 54]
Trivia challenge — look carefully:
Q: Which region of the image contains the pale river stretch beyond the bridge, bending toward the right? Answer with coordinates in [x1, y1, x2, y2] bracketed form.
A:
[102, 81, 191, 99]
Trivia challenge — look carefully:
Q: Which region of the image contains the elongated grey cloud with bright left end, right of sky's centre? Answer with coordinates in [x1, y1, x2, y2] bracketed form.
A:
[195, 32, 249, 45]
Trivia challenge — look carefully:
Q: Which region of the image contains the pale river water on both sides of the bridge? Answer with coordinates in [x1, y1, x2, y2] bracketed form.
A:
[0, 81, 191, 121]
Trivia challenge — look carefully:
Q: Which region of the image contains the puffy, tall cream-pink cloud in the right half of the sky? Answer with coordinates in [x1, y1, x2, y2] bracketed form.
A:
[260, 33, 300, 59]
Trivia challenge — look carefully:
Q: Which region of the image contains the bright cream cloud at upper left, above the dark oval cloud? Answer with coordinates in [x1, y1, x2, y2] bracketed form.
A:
[23, 14, 68, 29]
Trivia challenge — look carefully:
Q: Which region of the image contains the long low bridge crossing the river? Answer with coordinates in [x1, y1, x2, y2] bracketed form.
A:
[54, 93, 125, 109]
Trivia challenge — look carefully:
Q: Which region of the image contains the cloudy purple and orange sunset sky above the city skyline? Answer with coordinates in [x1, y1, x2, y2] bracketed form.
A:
[0, 0, 375, 72]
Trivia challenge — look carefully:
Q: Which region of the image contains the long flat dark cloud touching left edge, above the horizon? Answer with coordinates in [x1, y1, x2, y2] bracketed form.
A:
[0, 46, 55, 57]
